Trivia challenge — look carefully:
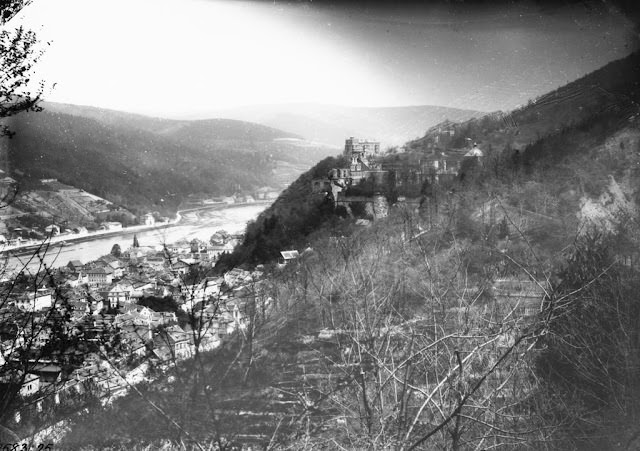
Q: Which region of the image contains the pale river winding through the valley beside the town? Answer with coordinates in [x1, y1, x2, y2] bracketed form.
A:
[1, 204, 269, 274]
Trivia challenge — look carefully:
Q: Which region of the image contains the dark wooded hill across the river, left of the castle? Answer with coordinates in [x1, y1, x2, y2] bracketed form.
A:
[4, 104, 328, 211]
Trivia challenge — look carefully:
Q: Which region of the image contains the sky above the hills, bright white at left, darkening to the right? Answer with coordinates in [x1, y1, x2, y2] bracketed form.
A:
[10, 0, 633, 117]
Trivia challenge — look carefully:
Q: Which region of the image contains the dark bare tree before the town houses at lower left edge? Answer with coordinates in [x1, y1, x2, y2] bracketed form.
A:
[0, 241, 100, 442]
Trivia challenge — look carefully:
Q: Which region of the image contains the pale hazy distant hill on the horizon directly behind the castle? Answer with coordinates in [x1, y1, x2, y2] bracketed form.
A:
[202, 104, 484, 147]
